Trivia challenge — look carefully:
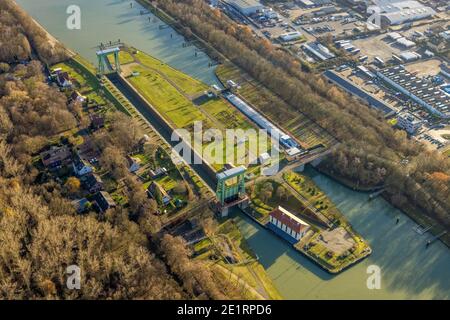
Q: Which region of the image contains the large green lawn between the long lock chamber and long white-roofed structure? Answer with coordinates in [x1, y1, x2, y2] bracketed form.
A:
[117, 51, 270, 171]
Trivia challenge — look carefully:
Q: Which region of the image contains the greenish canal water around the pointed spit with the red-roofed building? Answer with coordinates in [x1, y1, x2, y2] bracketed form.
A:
[230, 168, 450, 299]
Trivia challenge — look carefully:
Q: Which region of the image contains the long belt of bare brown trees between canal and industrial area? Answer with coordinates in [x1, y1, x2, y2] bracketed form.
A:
[150, 0, 450, 229]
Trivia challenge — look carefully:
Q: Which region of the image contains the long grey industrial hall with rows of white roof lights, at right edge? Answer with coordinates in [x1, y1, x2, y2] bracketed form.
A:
[377, 66, 450, 118]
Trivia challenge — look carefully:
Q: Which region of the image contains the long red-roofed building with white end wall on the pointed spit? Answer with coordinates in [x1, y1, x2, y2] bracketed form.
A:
[269, 206, 310, 241]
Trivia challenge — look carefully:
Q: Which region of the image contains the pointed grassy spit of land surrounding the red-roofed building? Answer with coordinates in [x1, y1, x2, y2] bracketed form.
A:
[243, 171, 372, 274]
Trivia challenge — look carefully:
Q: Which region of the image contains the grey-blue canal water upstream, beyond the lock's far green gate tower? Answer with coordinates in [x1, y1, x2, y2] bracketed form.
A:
[16, 0, 220, 85]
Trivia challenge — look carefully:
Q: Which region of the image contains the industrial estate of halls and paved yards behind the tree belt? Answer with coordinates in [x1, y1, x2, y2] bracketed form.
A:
[207, 0, 450, 153]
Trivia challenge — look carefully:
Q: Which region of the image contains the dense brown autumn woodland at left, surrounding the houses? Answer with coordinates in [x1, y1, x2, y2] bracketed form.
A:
[0, 0, 242, 299]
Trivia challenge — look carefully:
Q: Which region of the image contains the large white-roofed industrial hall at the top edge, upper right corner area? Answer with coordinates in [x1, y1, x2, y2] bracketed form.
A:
[376, 0, 436, 26]
